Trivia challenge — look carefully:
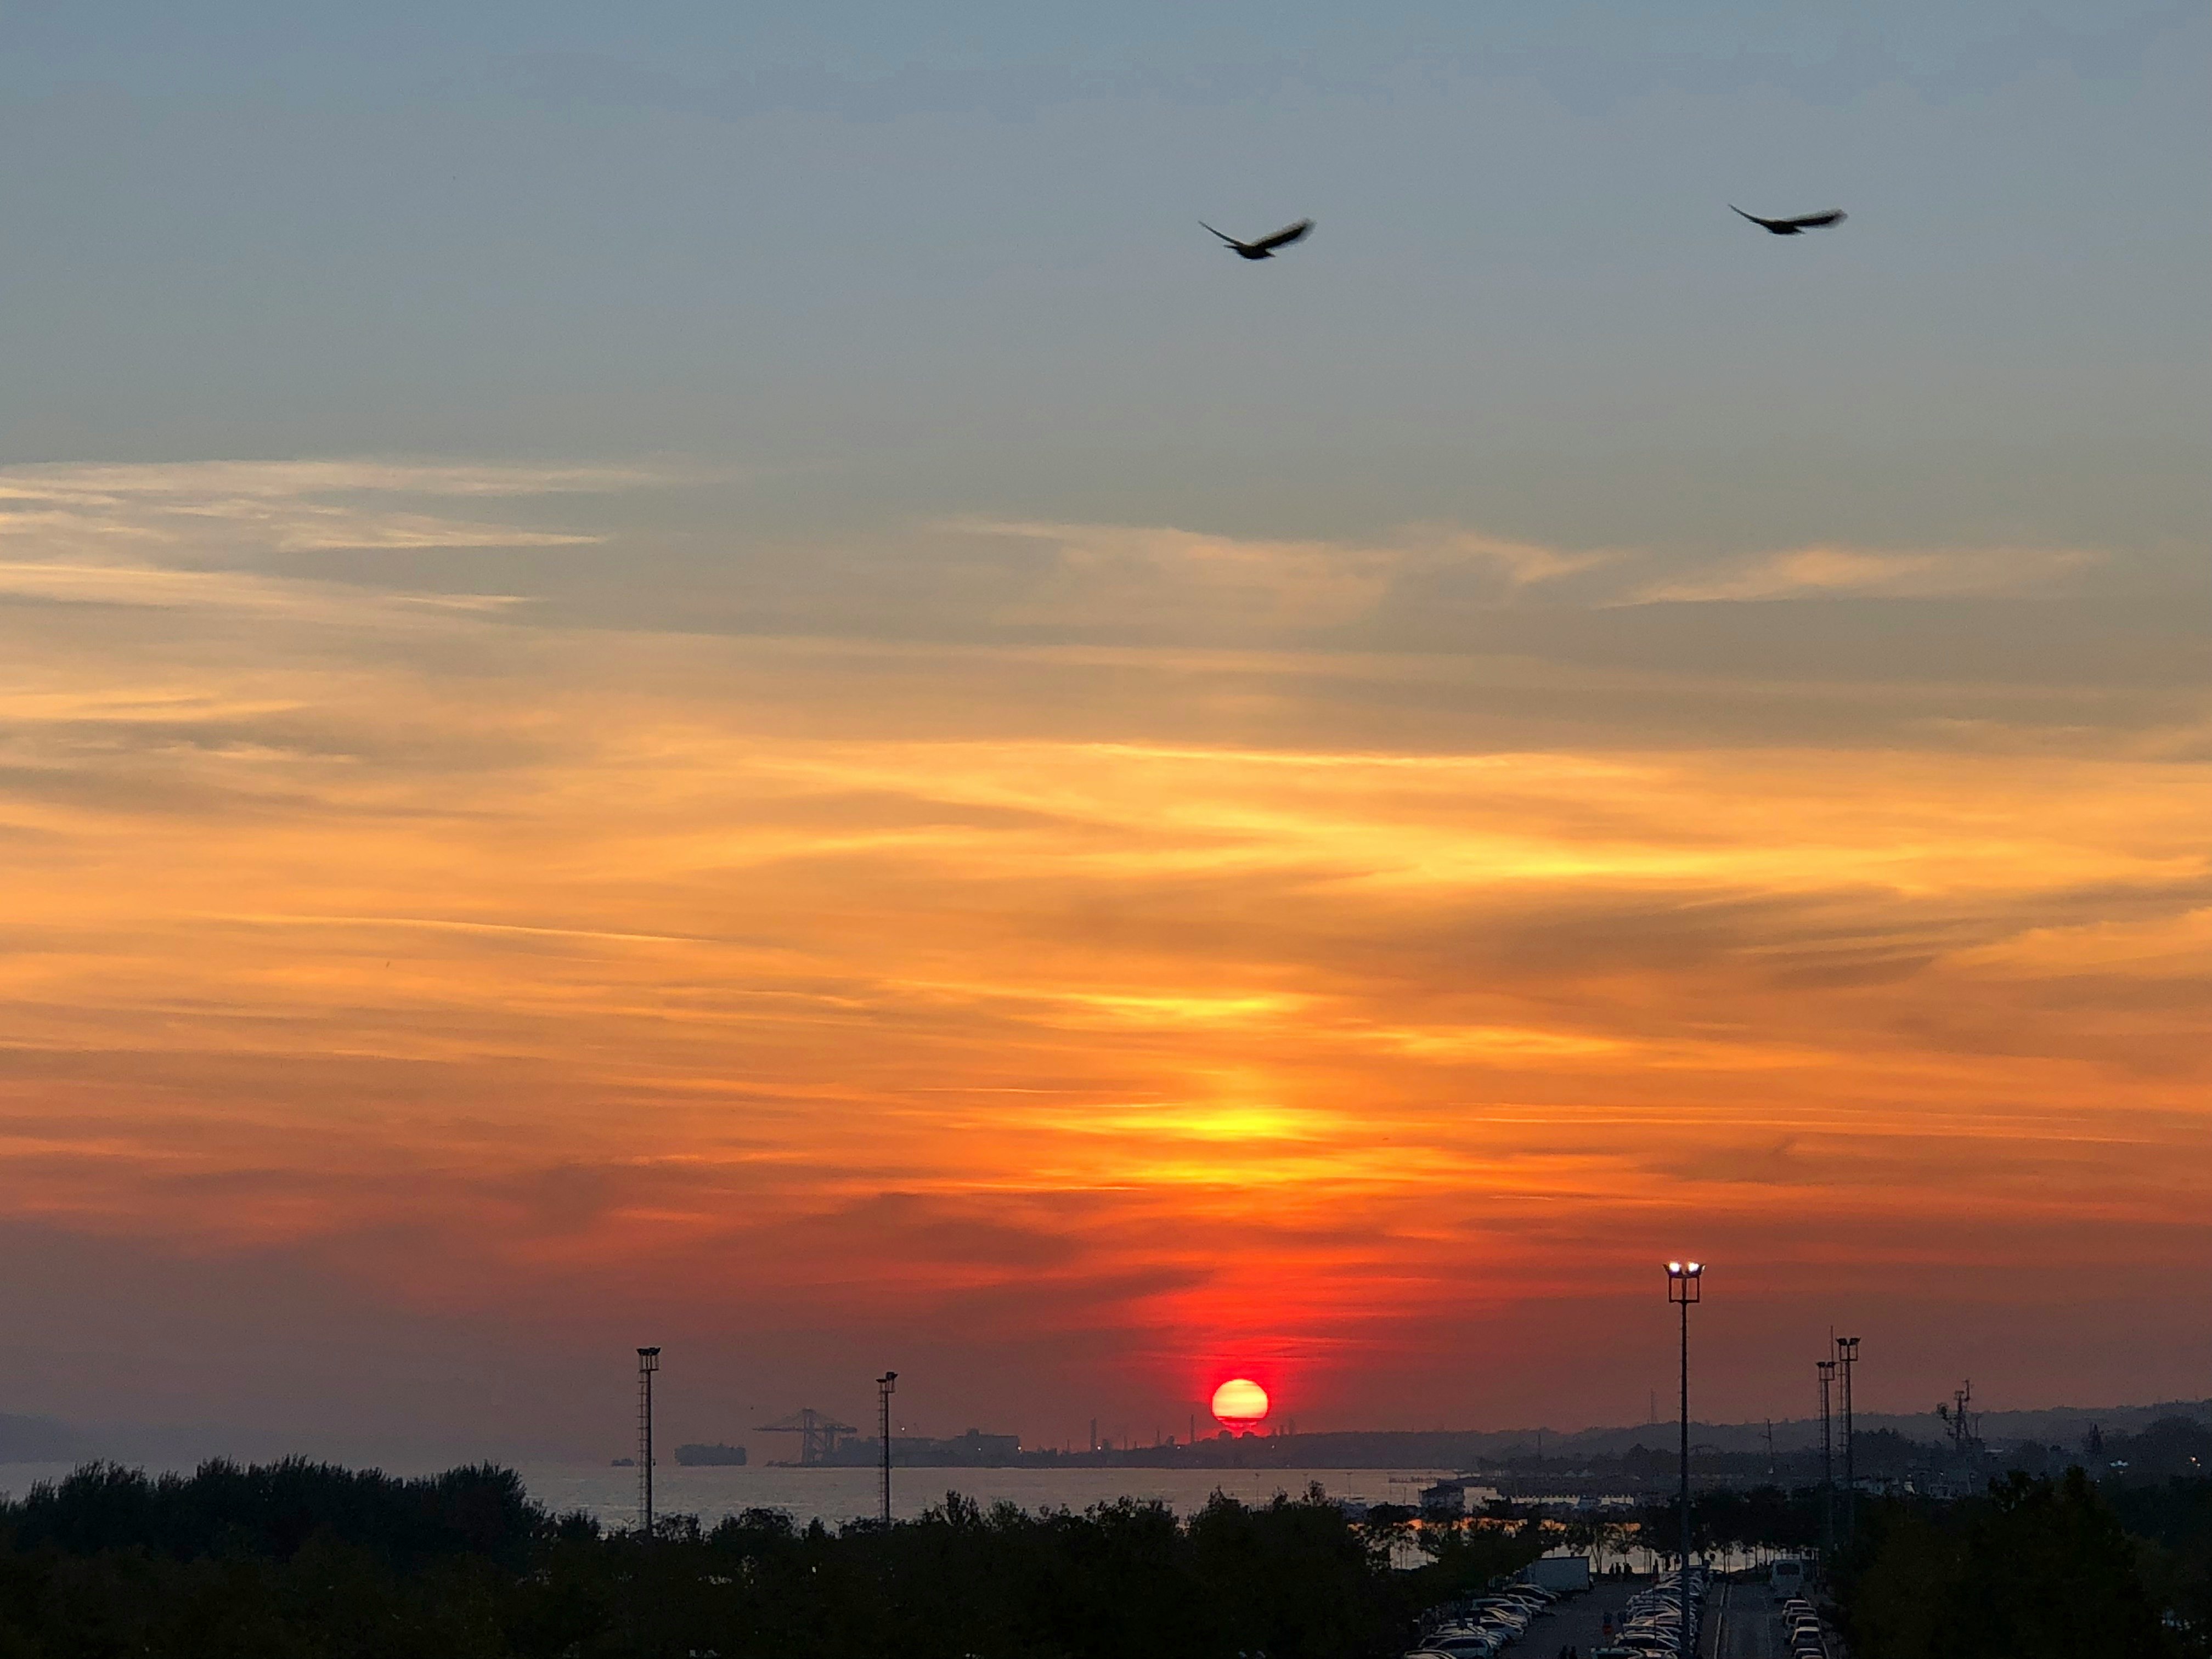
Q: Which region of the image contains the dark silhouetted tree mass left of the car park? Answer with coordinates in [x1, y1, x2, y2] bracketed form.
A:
[0, 1460, 1544, 1659]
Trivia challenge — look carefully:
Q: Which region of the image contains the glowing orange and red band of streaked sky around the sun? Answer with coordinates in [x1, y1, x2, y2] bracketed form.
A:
[0, 469, 2212, 1438]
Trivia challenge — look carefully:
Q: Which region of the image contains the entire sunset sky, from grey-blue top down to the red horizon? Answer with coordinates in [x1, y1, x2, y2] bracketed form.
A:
[0, 0, 2212, 1458]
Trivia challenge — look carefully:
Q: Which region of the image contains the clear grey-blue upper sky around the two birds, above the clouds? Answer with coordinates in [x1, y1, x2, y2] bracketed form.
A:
[0, 4, 2212, 560]
